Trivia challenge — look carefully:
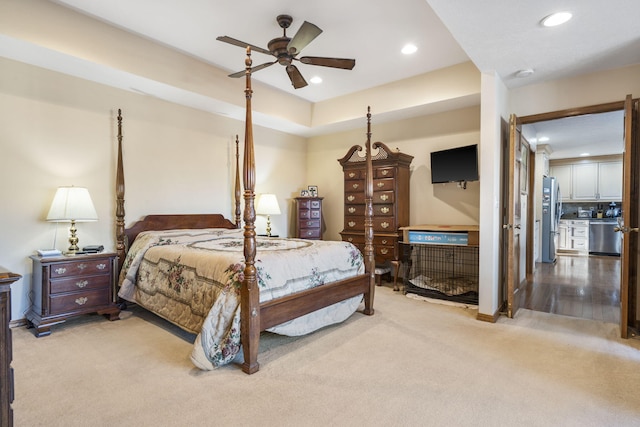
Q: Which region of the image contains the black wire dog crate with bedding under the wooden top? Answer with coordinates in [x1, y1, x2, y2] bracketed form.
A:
[404, 245, 478, 304]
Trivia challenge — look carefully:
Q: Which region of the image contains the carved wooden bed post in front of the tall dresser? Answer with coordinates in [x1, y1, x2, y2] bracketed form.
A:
[364, 106, 376, 315]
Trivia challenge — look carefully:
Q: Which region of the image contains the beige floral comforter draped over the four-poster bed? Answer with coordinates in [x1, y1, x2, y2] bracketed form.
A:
[118, 229, 364, 369]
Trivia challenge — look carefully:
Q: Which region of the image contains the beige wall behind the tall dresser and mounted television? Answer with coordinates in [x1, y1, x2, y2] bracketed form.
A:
[307, 107, 482, 240]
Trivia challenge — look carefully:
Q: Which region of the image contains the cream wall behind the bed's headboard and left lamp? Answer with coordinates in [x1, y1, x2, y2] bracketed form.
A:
[0, 59, 307, 320]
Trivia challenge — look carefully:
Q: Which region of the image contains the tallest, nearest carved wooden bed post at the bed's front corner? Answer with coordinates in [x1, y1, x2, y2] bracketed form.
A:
[240, 47, 261, 374]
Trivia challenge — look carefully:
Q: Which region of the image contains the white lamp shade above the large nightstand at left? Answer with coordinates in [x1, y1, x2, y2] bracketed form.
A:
[47, 187, 98, 222]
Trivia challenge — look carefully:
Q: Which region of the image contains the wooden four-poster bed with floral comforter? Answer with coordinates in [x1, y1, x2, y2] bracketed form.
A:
[116, 48, 375, 374]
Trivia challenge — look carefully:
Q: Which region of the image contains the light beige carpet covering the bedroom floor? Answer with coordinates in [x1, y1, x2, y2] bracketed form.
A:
[13, 287, 640, 427]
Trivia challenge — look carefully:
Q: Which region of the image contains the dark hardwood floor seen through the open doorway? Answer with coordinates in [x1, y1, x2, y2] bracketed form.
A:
[520, 255, 620, 323]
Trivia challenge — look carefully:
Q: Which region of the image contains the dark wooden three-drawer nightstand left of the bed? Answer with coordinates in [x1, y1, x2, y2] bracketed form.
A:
[27, 253, 120, 337]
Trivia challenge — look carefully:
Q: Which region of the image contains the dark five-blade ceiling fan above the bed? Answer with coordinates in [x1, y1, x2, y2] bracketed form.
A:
[216, 15, 356, 89]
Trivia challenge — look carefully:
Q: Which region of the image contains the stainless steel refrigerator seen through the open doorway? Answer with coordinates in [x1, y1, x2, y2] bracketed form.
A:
[542, 176, 562, 262]
